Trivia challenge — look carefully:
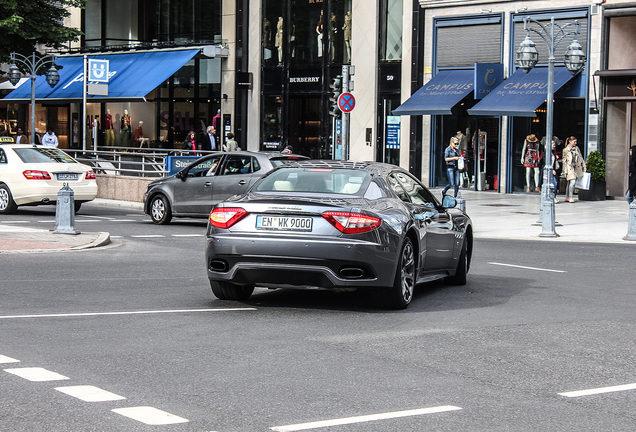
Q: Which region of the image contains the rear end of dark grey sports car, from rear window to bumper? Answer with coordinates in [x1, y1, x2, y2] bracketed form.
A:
[206, 168, 400, 293]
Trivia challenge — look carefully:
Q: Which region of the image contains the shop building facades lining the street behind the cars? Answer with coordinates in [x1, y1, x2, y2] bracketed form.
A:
[3, 0, 636, 197]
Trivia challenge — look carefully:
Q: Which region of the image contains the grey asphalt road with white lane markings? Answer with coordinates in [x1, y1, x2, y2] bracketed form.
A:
[0, 204, 636, 432]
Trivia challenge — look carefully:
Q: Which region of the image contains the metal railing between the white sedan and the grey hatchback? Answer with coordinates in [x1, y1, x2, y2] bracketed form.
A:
[65, 147, 207, 178]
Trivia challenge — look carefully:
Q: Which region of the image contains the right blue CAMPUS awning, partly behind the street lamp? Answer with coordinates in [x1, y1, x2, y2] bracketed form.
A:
[468, 67, 572, 117]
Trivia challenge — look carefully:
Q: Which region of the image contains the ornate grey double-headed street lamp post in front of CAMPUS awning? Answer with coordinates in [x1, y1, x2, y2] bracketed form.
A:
[515, 17, 586, 237]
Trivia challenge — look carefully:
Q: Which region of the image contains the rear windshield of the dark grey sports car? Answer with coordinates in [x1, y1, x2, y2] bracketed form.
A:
[256, 168, 371, 196]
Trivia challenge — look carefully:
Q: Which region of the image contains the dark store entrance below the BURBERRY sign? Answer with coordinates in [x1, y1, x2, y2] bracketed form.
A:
[287, 96, 323, 159]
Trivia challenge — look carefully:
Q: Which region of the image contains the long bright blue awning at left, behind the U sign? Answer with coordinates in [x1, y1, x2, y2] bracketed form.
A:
[4, 49, 200, 102]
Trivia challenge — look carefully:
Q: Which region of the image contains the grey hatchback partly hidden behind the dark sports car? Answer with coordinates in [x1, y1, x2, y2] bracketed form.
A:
[144, 151, 309, 224]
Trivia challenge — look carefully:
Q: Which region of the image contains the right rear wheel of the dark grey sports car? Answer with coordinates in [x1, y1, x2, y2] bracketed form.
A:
[373, 237, 415, 310]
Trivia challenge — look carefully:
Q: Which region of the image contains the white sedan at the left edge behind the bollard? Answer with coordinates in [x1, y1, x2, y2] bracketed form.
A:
[0, 143, 97, 213]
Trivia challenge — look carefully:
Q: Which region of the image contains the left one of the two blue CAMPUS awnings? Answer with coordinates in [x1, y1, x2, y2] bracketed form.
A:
[393, 69, 475, 115]
